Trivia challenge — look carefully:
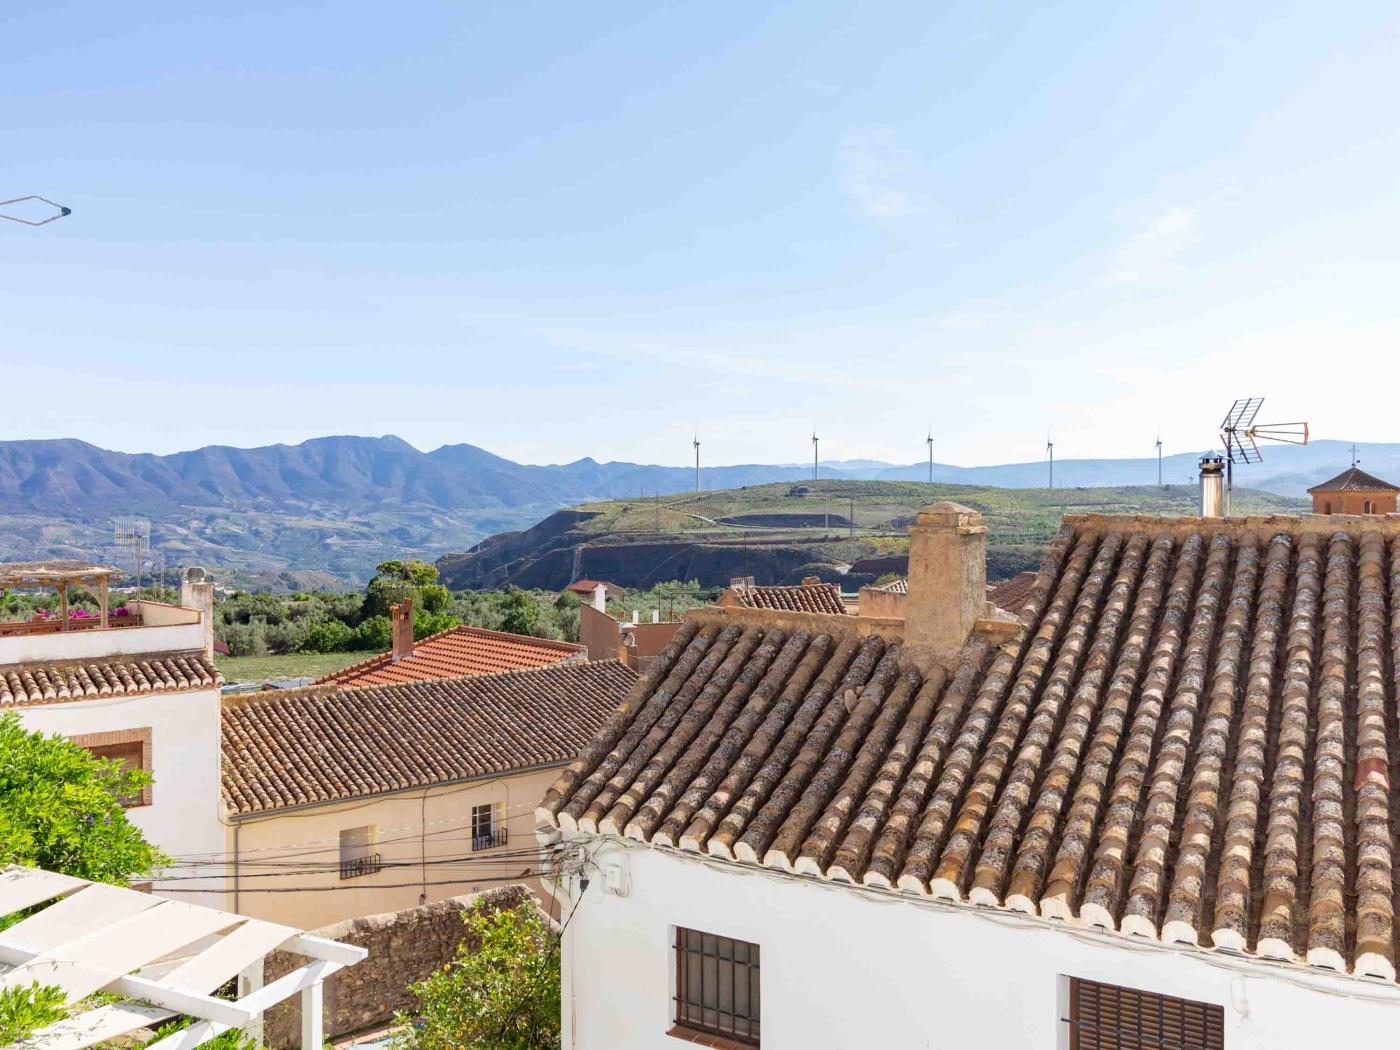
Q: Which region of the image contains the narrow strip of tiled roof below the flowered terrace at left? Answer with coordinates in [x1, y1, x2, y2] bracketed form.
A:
[0, 650, 224, 708]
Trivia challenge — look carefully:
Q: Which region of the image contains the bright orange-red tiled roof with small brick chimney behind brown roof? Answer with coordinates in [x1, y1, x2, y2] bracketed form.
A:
[316, 627, 588, 686]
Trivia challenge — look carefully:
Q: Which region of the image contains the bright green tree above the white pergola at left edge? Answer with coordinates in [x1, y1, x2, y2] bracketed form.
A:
[0, 713, 169, 885]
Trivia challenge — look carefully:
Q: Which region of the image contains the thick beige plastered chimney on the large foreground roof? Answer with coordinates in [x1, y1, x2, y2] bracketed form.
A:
[904, 501, 987, 661]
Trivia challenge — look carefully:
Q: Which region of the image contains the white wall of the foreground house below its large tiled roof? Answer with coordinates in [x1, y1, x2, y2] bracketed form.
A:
[563, 839, 1400, 1050]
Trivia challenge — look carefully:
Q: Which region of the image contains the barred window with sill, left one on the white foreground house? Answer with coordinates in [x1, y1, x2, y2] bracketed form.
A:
[676, 927, 759, 1046]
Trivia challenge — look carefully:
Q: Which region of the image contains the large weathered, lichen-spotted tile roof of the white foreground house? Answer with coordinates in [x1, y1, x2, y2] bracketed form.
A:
[539, 517, 1400, 980]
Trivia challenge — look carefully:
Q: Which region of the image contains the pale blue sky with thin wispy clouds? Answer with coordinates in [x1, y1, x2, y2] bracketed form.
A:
[0, 0, 1400, 463]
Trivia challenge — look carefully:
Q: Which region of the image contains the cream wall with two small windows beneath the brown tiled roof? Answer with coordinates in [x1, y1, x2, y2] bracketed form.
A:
[223, 767, 559, 930]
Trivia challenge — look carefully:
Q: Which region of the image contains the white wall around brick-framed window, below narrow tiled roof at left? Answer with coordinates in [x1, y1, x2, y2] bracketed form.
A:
[17, 686, 224, 907]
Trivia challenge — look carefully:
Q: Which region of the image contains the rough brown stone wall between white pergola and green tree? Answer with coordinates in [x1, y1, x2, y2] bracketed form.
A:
[263, 886, 539, 1047]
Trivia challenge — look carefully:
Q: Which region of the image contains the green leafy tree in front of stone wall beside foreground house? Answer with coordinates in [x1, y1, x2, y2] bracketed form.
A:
[395, 903, 560, 1050]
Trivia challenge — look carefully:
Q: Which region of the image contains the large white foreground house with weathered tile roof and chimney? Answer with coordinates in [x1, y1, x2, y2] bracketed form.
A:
[536, 504, 1400, 1050]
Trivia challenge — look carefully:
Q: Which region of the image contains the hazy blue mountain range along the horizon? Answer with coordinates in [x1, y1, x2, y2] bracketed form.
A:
[0, 435, 1383, 585]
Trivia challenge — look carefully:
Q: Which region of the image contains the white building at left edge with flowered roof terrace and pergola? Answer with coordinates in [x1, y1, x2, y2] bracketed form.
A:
[0, 563, 224, 906]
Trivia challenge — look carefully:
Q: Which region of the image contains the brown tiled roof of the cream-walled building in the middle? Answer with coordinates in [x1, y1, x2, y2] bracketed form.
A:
[223, 659, 637, 815]
